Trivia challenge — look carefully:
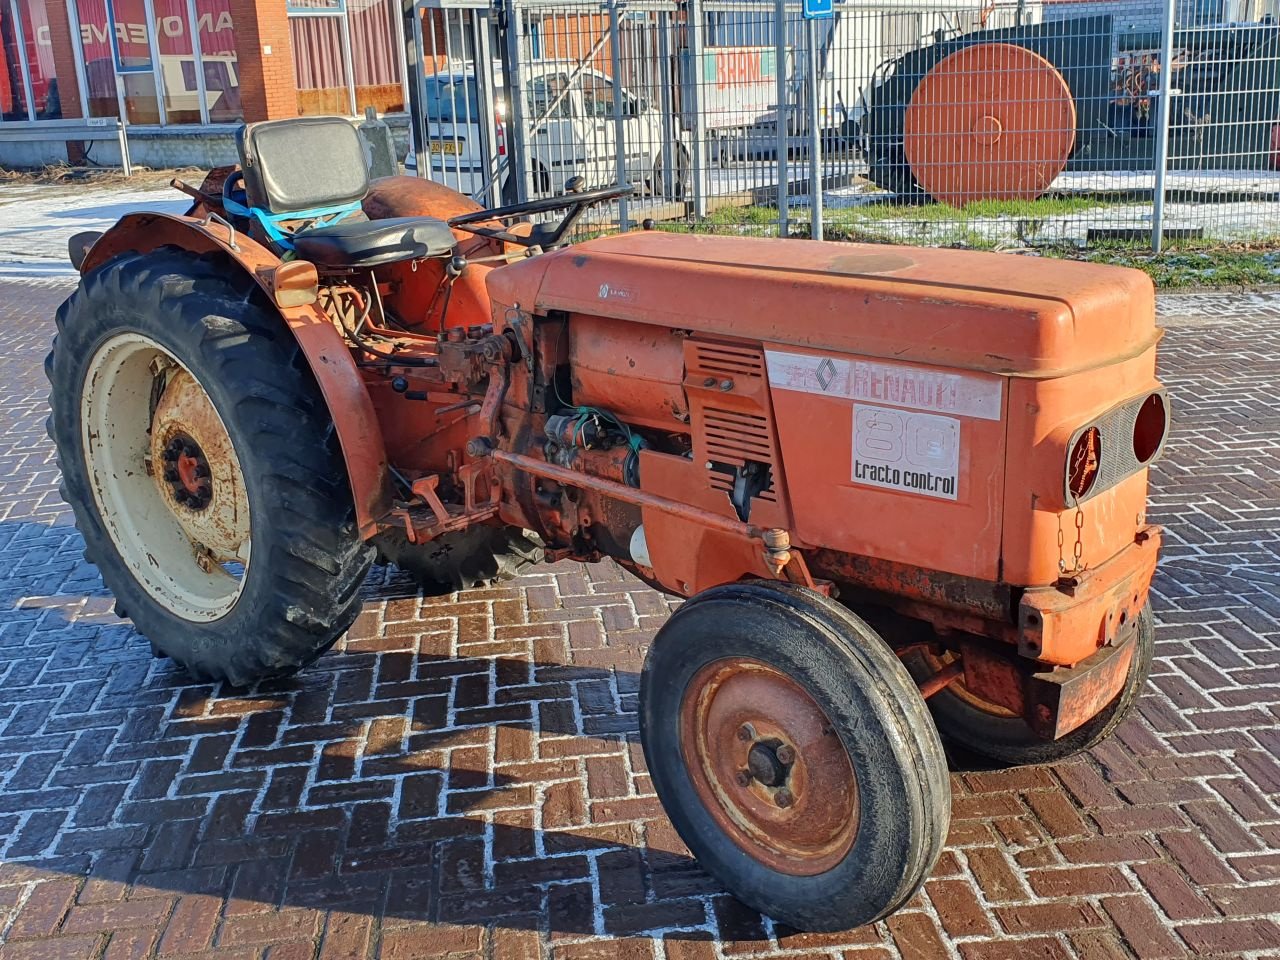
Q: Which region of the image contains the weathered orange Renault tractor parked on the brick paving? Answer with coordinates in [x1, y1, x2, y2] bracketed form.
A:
[47, 118, 1169, 929]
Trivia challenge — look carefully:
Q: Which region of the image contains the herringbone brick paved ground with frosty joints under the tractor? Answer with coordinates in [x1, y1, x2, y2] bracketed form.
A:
[0, 277, 1280, 960]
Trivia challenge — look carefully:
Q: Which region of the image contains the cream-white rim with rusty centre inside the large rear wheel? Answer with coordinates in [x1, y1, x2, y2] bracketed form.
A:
[81, 333, 250, 622]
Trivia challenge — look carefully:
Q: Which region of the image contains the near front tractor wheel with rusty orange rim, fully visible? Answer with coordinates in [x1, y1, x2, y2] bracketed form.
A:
[640, 581, 951, 931]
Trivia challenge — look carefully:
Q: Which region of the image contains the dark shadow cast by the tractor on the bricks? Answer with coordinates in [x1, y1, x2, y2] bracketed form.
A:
[0, 537, 772, 940]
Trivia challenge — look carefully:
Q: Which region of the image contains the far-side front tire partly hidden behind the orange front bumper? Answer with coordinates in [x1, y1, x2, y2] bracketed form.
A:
[904, 604, 1156, 767]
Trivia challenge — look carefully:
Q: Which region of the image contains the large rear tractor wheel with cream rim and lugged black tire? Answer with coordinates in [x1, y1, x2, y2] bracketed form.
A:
[45, 247, 374, 686]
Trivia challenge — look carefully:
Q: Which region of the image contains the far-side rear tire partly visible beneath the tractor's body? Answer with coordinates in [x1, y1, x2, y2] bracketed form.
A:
[376, 525, 543, 596]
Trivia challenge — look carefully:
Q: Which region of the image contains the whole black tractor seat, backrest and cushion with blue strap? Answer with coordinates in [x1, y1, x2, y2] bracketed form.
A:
[235, 116, 456, 269]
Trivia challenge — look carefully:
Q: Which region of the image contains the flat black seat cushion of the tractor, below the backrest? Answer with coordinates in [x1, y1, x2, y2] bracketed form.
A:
[293, 216, 456, 268]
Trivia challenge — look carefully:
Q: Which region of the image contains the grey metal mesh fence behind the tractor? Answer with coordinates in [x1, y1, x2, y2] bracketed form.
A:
[406, 0, 1280, 248]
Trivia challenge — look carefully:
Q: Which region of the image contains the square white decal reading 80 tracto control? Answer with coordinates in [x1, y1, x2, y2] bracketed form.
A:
[852, 403, 960, 500]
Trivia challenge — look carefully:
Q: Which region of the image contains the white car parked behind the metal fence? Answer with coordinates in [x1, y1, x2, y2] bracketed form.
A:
[406, 60, 689, 200]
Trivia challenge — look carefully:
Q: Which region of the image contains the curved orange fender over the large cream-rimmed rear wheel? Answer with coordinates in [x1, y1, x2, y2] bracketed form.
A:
[79, 214, 390, 539]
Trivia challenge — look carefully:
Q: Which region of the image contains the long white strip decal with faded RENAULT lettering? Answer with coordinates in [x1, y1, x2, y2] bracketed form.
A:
[764, 349, 1001, 420]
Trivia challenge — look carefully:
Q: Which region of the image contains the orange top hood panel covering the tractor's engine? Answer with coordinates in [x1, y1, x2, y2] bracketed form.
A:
[488, 232, 1157, 378]
